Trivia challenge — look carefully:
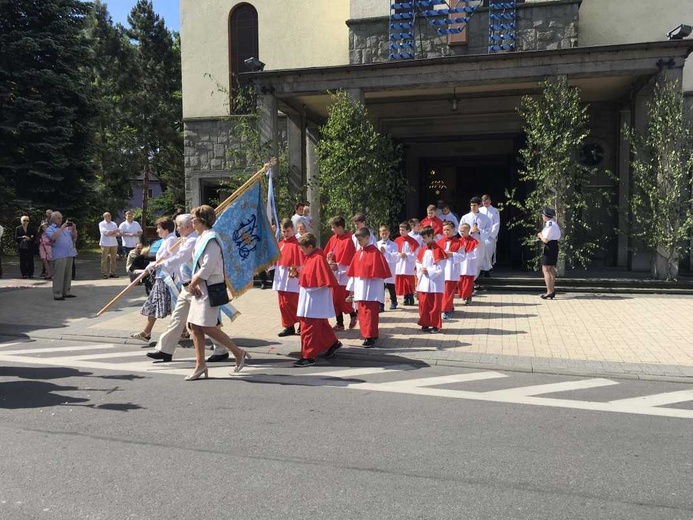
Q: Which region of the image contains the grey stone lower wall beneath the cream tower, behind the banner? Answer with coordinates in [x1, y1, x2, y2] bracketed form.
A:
[183, 116, 286, 208]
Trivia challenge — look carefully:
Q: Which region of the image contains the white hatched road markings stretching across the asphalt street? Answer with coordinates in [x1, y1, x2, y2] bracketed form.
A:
[0, 343, 693, 419]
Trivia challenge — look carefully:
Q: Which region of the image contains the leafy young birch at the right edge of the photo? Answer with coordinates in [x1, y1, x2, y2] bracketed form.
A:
[625, 76, 693, 280]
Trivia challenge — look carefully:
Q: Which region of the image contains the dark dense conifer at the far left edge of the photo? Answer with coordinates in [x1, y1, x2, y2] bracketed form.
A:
[0, 0, 94, 218]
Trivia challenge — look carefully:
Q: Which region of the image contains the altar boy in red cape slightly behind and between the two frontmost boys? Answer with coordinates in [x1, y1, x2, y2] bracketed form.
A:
[325, 216, 357, 330]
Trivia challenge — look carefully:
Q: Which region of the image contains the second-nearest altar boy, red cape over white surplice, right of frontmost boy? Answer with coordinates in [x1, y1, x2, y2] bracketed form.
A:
[347, 228, 392, 348]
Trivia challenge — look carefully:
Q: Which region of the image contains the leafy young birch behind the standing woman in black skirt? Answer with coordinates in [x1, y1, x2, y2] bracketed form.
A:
[506, 77, 602, 270]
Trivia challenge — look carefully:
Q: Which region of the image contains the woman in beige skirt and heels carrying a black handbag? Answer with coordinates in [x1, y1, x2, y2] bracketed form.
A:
[183, 205, 250, 381]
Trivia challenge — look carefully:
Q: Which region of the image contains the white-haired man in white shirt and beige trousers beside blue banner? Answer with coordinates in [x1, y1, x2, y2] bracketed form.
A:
[147, 213, 229, 363]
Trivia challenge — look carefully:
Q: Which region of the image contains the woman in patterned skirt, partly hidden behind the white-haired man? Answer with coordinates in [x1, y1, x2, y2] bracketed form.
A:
[130, 217, 178, 342]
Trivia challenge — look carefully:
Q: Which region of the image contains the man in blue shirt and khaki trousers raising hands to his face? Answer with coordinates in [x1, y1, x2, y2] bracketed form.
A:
[46, 211, 77, 300]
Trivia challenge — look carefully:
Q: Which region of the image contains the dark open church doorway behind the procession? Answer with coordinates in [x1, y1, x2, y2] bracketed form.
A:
[418, 154, 523, 268]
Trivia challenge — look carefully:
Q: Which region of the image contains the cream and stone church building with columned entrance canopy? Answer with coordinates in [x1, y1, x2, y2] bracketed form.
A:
[181, 0, 693, 270]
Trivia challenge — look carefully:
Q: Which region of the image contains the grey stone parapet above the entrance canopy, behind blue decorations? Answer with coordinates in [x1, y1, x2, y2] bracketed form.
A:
[347, 0, 580, 65]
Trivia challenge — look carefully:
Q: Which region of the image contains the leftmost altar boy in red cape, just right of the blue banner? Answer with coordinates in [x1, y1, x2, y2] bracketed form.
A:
[272, 218, 303, 337]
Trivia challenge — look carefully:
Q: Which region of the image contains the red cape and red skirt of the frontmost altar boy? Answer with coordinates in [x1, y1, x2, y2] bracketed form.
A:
[298, 249, 339, 359]
